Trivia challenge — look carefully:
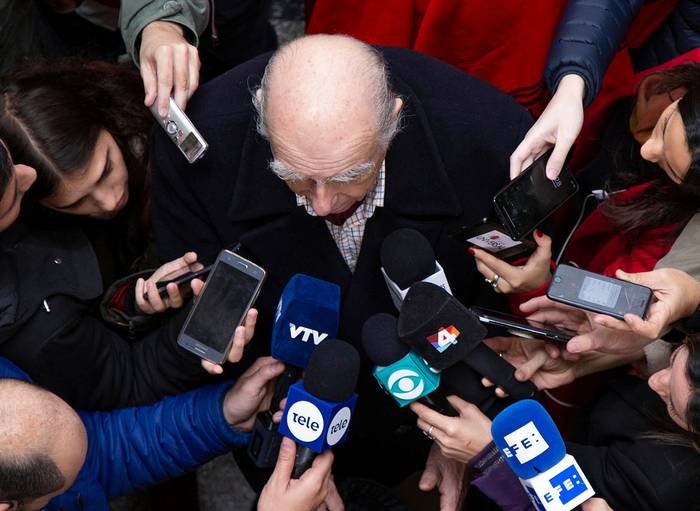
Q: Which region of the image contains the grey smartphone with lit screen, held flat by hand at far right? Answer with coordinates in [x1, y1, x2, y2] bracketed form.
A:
[547, 264, 652, 319]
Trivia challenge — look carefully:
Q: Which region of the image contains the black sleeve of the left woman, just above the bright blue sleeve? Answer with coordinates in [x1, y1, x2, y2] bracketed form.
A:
[8, 296, 208, 410]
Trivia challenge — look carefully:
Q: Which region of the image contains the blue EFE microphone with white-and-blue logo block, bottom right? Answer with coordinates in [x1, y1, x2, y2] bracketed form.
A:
[491, 399, 595, 511]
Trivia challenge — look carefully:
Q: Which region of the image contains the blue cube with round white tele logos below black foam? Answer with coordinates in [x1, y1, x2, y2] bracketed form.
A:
[279, 381, 357, 453]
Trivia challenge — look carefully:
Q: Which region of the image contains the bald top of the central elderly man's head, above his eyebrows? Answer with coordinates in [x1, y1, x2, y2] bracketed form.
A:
[254, 35, 397, 152]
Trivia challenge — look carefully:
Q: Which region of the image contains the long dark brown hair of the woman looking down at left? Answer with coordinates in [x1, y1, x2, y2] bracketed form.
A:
[0, 59, 153, 206]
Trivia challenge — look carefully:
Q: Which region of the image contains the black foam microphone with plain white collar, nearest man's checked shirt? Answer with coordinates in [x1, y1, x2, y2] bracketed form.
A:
[379, 228, 452, 310]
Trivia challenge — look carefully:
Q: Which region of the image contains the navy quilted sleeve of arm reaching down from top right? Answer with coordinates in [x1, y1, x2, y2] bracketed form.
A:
[544, 0, 644, 106]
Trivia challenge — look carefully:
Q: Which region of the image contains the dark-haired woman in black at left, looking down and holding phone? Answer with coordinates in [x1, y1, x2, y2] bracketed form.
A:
[0, 60, 256, 409]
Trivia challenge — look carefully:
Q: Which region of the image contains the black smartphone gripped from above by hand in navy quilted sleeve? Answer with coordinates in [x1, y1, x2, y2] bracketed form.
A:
[493, 151, 578, 240]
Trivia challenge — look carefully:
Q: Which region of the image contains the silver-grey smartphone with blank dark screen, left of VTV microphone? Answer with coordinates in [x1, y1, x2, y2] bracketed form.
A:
[177, 250, 265, 364]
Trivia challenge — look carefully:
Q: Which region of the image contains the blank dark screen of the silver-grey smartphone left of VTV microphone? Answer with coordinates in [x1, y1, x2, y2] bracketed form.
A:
[183, 262, 259, 353]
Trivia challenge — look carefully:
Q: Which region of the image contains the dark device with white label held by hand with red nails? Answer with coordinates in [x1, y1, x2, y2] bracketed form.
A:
[449, 218, 536, 261]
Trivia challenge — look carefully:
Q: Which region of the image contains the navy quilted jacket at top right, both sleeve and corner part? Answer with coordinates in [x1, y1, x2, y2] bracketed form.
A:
[544, 0, 700, 105]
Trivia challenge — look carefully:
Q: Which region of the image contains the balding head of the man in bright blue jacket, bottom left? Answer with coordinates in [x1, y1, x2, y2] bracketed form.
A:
[0, 379, 87, 509]
